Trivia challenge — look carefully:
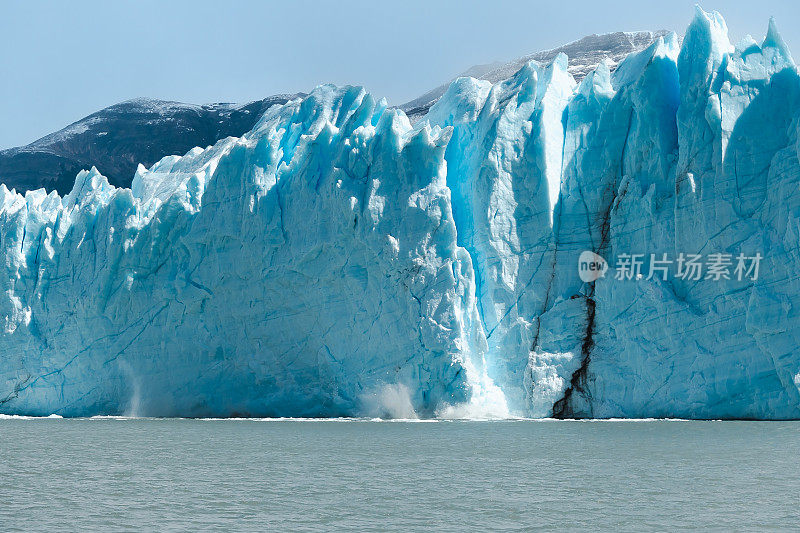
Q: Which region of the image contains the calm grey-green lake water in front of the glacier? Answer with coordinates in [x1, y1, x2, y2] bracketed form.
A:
[0, 417, 800, 531]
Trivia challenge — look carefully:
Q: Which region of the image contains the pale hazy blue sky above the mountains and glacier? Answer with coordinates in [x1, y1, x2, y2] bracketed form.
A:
[0, 0, 800, 148]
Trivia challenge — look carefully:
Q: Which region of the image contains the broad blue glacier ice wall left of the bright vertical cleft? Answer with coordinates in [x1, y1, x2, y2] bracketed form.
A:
[0, 87, 500, 416]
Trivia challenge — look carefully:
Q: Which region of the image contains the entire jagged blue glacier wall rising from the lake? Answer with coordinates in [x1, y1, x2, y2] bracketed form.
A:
[0, 8, 800, 419]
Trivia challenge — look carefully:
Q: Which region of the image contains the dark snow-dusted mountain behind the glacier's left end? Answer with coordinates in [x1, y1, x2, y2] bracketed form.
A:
[0, 94, 302, 195]
